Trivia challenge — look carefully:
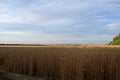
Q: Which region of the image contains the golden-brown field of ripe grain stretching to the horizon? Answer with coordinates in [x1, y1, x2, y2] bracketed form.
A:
[0, 45, 120, 80]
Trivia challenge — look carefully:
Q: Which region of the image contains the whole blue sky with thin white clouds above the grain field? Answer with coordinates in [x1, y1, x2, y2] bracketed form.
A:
[0, 0, 120, 44]
